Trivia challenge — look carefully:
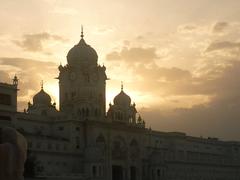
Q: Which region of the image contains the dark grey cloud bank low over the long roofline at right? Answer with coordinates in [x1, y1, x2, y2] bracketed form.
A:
[140, 93, 240, 140]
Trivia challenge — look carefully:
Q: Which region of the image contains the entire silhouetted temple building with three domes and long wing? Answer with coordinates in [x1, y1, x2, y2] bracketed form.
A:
[0, 32, 240, 180]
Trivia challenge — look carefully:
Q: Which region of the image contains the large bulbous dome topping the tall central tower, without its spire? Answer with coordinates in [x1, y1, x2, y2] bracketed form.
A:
[67, 38, 98, 66]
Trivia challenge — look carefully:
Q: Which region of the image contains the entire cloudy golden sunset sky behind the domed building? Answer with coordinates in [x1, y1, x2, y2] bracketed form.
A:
[0, 0, 240, 140]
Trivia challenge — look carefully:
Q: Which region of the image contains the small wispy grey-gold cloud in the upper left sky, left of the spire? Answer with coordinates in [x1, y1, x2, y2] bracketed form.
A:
[13, 32, 66, 52]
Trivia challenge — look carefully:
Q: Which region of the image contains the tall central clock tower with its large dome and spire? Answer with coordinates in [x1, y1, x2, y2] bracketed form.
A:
[58, 32, 107, 119]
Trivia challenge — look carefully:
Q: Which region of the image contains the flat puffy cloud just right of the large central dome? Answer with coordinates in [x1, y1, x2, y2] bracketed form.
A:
[106, 47, 159, 64]
